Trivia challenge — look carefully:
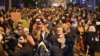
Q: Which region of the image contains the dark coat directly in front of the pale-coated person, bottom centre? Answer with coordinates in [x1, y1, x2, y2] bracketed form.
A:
[50, 35, 63, 56]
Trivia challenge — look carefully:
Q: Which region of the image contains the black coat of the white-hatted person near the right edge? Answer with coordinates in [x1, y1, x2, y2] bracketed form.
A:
[85, 32, 97, 56]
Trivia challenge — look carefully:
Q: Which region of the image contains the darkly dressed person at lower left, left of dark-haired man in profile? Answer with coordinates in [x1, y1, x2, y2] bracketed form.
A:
[3, 27, 19, 56]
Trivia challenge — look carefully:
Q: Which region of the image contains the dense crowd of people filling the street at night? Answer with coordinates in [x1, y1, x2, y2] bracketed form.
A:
[0, 3, 100, 56]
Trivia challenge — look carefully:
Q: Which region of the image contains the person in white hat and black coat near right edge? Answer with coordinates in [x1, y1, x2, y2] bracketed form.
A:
[85, 25, 97, 56]
